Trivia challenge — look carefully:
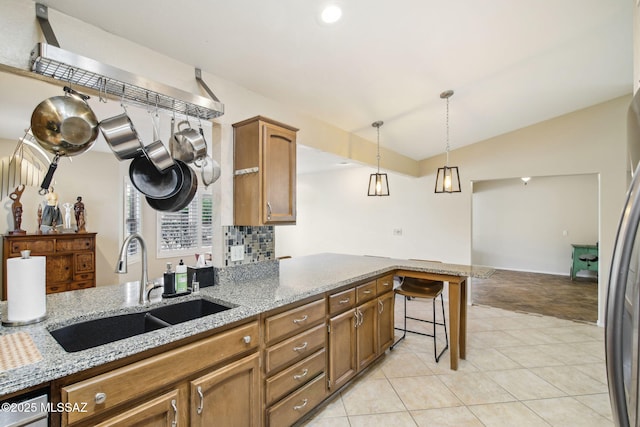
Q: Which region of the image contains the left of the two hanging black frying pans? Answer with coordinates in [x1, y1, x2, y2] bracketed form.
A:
[129, 154, 185, 199]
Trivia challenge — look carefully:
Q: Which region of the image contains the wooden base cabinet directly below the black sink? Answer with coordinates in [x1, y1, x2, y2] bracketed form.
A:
[60, 321, 261, 427]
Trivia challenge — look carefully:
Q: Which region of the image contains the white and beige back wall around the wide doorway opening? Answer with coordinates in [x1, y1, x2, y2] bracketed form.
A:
[276, 96, 630, 326]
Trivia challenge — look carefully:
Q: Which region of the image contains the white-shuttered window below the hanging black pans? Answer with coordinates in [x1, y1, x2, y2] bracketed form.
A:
[157, 190, 213, 258]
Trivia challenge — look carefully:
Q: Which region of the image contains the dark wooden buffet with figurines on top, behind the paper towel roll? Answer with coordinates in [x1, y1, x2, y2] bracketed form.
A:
[2, 233, 96, 300]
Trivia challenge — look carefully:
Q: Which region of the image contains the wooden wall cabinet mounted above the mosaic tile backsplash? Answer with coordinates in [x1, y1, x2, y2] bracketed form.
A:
[233, 116, 298, 225]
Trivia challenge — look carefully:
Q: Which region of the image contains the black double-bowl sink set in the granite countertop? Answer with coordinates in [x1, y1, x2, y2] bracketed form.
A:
[49, 299, 231, 353]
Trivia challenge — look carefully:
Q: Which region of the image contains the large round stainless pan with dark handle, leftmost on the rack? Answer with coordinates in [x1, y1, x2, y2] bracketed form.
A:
[31, 86, 98, 194]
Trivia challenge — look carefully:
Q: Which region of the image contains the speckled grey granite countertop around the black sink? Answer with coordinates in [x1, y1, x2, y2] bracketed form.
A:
[0, 254, 494, 398]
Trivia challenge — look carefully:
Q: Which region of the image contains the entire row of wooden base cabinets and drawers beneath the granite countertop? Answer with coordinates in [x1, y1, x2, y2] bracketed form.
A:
[51, 274, 394, 427]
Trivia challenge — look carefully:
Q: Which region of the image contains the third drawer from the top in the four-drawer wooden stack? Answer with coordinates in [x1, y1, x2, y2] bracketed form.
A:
[266, 349, 326, 405]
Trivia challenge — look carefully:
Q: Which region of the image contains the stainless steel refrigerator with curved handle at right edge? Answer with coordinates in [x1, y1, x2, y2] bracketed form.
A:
[605, 91, 640, 427]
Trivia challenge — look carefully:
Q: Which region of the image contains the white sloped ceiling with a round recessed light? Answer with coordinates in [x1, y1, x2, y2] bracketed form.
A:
[1, 0, 635, 166]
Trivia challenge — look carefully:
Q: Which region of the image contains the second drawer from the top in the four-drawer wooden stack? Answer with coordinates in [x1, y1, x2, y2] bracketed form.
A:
[265, 324, 327, 374]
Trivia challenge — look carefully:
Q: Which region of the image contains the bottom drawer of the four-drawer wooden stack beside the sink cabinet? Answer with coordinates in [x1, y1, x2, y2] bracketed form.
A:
[267, 374, 327, 427]
